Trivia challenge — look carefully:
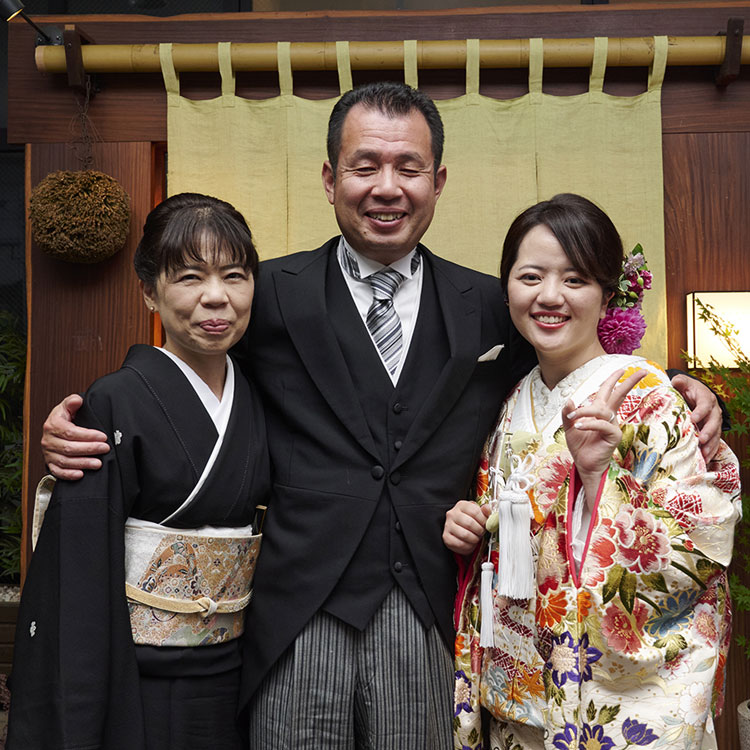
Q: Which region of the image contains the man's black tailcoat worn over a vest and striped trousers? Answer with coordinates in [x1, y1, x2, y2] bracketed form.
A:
[242, 237, 534, 703]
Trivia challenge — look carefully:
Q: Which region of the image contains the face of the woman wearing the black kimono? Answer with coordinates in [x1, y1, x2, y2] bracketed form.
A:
[143, 254, 255, 364]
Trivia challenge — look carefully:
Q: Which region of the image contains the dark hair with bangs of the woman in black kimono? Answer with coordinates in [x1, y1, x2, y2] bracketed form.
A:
[133, 193, 258, 289]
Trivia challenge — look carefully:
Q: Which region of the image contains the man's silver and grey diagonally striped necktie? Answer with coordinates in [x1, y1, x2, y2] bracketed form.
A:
[339, 242, 420, 375]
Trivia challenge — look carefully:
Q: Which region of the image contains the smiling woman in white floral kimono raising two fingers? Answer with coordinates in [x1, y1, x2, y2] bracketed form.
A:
[444, 194, 739, 750]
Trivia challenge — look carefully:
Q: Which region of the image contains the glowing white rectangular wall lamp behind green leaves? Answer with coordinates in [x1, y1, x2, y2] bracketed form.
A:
[687, 292, 750, 367]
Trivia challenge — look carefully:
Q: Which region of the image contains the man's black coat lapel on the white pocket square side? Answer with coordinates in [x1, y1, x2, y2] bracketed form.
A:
[392, 256, 481, 469]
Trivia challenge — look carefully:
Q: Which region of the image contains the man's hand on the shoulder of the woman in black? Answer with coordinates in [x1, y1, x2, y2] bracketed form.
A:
[42, 393, 109, 479]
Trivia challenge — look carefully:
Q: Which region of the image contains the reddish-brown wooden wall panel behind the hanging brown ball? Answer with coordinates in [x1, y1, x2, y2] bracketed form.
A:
[24, 143, 152, 567]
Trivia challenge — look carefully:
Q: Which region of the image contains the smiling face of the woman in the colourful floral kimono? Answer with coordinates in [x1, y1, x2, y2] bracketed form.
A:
[508, 224, 607, 385]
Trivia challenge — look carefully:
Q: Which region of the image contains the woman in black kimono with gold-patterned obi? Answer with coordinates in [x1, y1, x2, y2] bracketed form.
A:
[7, 193, 269, 750]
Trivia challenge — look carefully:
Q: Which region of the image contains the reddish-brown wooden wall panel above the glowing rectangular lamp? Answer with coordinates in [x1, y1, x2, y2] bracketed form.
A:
[663, 132, 750, 367]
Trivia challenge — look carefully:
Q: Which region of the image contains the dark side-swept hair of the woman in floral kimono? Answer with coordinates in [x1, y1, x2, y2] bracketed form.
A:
[500, 193, 623, 298]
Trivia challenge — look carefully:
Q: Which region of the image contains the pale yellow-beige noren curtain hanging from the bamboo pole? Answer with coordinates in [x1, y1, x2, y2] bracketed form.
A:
[160, 37, 667, 363]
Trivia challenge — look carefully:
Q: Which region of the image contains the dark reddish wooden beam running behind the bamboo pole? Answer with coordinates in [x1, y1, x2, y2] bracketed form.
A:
[8, 3, 750, 143]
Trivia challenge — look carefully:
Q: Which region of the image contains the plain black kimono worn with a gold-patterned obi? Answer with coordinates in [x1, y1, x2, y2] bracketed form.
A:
[7, 346, 269, 750]
